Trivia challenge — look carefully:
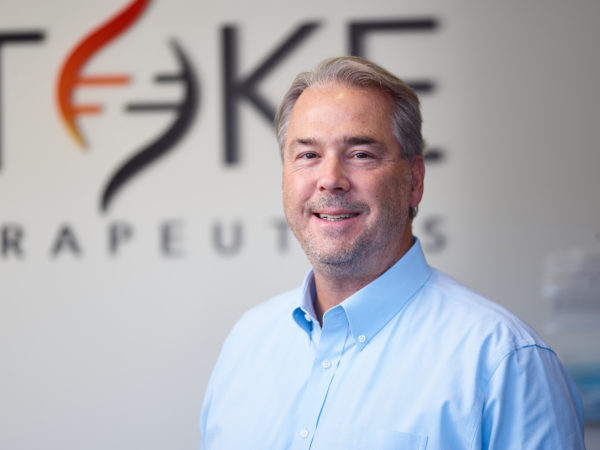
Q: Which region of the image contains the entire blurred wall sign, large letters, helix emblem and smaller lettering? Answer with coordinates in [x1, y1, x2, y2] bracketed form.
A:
[0, 11, 447, 260]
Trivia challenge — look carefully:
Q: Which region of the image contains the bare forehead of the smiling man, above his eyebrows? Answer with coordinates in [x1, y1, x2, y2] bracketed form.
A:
[288, 83, 392, 142]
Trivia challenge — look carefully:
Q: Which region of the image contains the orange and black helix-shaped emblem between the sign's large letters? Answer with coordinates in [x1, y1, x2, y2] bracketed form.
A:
[56, 0, 199, 211]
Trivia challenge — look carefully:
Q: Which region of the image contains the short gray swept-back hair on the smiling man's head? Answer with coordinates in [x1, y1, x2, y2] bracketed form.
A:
[275, 56, 424, 160]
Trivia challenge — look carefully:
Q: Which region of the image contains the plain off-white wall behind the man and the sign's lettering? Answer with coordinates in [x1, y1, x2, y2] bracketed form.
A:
[0, 0, 600, 450]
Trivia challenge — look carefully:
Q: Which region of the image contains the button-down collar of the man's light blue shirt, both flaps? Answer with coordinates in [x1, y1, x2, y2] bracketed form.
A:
[293, 238, 431, 350]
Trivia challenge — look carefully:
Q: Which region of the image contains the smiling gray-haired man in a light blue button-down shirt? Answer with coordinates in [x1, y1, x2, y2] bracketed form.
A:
[201, 57, 584, 450]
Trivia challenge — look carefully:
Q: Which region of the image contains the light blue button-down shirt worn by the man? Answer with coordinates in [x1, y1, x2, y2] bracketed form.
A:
[201, 240, 584, 450]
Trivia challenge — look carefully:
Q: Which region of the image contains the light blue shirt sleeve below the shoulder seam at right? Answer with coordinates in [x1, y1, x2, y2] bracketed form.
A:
[481, 345, 585, 450]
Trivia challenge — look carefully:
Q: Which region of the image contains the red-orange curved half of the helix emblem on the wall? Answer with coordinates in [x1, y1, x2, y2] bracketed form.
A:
[57, 0, 150, 147]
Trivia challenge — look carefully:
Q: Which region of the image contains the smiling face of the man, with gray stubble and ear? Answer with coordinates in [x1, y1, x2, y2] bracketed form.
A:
[283, 84, 424, 275]
